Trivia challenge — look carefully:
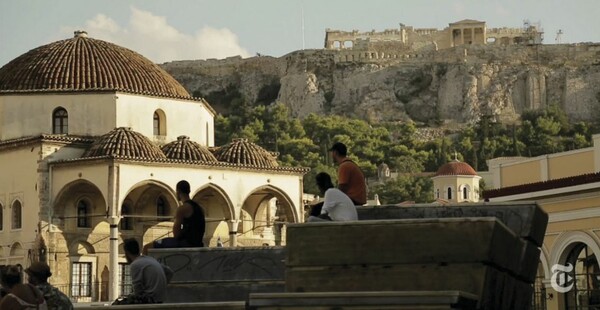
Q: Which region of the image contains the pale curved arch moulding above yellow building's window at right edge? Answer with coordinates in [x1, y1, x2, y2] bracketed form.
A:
[550, 231, 600, 266]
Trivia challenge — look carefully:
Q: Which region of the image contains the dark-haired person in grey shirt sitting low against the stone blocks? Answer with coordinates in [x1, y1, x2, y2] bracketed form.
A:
[113, 238, 173, 305]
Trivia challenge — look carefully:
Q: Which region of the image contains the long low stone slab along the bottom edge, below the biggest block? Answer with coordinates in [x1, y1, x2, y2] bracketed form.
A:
[248, 291, 477, 310]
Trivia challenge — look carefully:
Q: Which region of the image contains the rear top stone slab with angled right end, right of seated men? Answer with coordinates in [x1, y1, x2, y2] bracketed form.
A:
[357, 202, 548, 246]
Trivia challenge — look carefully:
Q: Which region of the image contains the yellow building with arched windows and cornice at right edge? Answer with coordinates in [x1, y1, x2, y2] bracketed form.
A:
[483, 135, 600, 310]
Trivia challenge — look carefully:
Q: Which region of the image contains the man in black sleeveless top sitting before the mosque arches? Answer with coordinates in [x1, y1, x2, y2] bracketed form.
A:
[143, 180, 206, 255]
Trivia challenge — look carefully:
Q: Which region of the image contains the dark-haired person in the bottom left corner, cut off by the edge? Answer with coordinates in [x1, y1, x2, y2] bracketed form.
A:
[0, 265, 48, 310]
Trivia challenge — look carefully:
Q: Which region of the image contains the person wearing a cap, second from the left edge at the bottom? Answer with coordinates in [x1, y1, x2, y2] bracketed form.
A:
[25, 262, 73, 310]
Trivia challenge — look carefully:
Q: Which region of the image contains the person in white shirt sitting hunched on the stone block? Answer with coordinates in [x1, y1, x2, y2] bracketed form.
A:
[308, 172, 358, 222]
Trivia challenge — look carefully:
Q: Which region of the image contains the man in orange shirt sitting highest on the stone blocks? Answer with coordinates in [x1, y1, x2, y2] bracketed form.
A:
[329, 142, 367, 206]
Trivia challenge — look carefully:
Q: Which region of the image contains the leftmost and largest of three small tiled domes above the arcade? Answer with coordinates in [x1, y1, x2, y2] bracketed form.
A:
[83, 127, 166, 159]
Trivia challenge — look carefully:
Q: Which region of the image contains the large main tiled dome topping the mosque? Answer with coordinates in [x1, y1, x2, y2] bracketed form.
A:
[0, 31, 191, 98]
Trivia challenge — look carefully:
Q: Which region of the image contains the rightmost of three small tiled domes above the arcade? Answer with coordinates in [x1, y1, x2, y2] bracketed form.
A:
[215, 139, 279, 167]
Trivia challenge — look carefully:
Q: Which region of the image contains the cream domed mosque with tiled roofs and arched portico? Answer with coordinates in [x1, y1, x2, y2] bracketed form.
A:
[0, 31, 307, 301]
